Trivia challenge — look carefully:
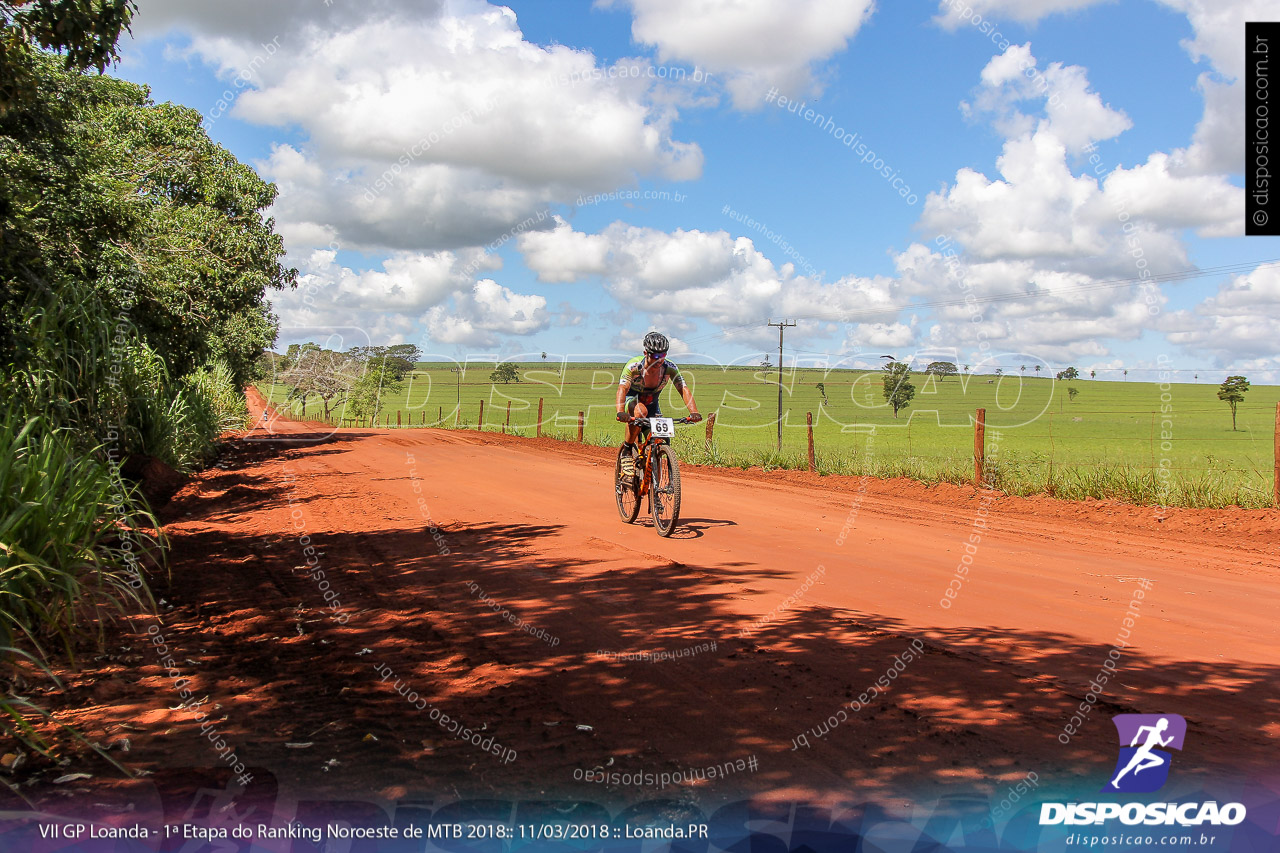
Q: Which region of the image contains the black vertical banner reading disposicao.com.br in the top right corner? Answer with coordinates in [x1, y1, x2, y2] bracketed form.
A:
[1244, 20, 1280, 237]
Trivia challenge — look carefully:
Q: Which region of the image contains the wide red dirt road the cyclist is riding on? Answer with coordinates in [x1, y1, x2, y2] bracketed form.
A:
[12, 394, 1280, 819]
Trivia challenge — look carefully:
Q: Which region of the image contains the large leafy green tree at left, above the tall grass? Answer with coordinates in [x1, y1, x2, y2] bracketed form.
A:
[0, 54, 297, 384]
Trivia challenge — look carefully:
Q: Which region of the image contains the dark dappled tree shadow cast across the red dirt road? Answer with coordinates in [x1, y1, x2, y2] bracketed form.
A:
[17, 425, 1280, 819]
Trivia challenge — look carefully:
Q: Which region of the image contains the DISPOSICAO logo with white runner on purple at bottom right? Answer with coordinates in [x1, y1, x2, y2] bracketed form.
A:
[1039, 713, 1245, 826]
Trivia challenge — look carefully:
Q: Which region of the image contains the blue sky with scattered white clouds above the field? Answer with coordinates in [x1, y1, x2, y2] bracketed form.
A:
[116, 0, 1280, 382]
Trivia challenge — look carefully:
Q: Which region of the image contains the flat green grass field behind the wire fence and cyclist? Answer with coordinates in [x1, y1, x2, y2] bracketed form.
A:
[262, 362, 1280, 507]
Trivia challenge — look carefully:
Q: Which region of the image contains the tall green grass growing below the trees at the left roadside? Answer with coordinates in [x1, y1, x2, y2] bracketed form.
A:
[0, 280, 227, 784]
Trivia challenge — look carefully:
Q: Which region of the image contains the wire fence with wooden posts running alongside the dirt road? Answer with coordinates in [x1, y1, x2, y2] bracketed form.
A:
[259, 387, 1280, 507]
